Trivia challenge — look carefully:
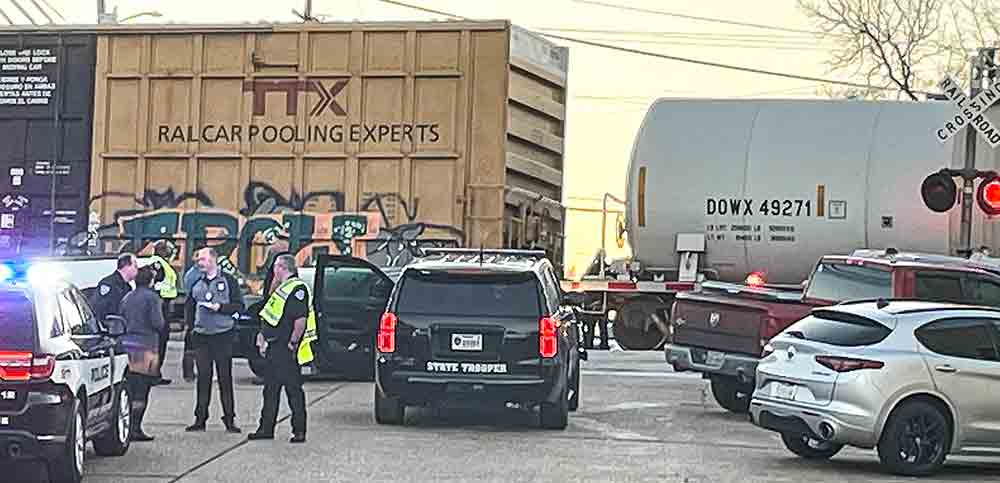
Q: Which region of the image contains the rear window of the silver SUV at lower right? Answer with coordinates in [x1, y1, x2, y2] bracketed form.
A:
[784, 310, 892, 347]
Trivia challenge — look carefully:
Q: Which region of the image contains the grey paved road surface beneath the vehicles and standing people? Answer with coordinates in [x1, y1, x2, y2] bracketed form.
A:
[0, 343, 1000, 483]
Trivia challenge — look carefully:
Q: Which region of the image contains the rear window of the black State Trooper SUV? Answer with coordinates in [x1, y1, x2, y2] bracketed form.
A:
[396, 271, 541, 317]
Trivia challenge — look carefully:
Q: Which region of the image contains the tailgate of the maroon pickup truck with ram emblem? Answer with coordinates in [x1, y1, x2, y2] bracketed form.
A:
[672, 293, 768, 355]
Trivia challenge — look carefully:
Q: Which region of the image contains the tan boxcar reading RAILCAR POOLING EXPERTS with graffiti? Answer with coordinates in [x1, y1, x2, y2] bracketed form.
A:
[90, 21, 567, 280]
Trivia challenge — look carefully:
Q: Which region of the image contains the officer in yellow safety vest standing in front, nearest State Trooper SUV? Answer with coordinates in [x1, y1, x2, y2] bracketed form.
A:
[248, 254, 316, 443]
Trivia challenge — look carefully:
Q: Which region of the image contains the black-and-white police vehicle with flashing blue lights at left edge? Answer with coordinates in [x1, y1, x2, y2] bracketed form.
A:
[0, 263, 131, 482]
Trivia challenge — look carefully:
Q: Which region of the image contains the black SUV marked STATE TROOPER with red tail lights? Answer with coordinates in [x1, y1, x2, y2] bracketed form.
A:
[375, 249, 586, 429]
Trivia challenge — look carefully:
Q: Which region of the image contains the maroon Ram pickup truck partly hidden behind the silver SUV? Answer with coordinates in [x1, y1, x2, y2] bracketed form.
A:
[664, 250, 1000, 413]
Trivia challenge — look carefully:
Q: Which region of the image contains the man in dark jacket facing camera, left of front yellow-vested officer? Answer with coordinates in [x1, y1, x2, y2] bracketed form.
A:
[185, 248, 243, 433]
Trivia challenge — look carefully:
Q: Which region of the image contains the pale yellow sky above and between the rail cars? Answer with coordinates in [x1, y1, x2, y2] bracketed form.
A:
[9, 0, 860, 275]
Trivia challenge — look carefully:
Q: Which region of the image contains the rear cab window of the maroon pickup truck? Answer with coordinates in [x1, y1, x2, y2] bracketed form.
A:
[806, 263, 892, 302]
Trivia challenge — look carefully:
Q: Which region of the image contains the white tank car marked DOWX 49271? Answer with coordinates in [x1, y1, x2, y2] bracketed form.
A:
[626, 99, 984, 284]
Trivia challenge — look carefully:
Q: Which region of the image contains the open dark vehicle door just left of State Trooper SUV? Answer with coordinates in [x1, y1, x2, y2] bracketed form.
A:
[312, 255, 399, 379]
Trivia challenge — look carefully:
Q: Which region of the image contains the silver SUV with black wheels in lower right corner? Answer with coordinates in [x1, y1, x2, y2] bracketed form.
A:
[750, 300, 1000, 476]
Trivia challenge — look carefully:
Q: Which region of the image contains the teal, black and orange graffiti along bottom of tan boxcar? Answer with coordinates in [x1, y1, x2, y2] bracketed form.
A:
[64, 181, 465, 275]
